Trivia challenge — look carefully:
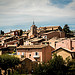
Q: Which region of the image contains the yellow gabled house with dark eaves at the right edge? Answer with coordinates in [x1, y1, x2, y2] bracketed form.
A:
[52, 47, 75, 60]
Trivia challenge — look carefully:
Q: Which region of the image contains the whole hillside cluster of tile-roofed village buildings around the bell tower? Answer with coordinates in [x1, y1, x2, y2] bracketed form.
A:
[0, 25, 75, 62]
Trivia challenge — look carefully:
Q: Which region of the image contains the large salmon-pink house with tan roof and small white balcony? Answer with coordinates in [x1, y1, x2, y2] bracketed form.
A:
[17, 45, 54, 62]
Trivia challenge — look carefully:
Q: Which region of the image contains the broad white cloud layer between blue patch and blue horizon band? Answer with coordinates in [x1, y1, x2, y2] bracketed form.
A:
[0, 0, 75, 25]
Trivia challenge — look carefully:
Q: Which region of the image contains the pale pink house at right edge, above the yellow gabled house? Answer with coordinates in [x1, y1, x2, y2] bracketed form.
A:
[56, 38, 75, 50]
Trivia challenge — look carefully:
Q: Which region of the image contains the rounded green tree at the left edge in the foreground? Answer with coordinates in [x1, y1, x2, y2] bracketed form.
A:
[0, 55, 20, 75]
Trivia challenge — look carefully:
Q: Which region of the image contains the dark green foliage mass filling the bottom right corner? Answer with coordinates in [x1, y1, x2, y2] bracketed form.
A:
[34, 55, 75, 75]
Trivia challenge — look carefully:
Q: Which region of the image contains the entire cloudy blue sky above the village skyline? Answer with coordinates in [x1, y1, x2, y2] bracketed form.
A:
[0, 0, 75, 32]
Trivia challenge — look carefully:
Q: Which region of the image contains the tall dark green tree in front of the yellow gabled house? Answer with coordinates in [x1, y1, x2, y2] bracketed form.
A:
[48, 54, 66, 75]
